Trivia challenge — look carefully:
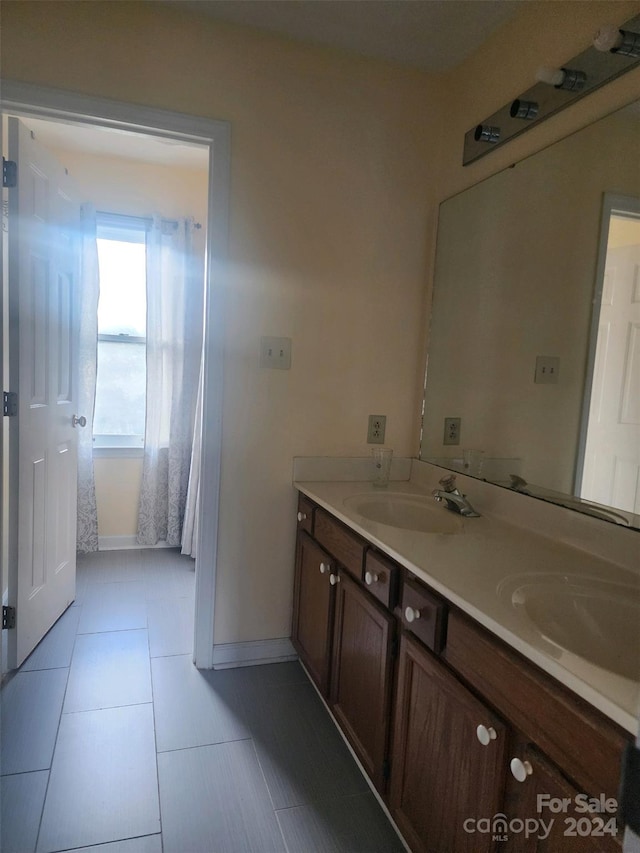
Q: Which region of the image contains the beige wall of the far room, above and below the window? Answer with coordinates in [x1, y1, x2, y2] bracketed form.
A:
[37, 142, 207, 536]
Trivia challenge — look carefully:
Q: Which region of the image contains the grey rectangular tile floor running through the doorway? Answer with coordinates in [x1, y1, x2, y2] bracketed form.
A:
[0, 550, 404, 853]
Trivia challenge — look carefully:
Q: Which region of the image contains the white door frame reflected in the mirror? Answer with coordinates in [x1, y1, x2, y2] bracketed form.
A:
[573, 193, 640, 497]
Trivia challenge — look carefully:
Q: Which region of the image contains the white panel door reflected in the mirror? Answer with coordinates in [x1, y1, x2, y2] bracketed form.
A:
[578, 196, 640, 513]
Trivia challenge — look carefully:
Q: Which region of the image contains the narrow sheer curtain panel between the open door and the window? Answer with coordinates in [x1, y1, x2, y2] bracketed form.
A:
[76, 204, 100, 553]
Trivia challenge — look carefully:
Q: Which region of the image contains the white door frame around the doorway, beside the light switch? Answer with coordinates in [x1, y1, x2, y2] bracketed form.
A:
[0, 80, 231, 669]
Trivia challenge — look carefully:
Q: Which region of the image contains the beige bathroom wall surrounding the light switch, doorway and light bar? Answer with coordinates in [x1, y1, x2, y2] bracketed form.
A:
[2, 0, 640, 642]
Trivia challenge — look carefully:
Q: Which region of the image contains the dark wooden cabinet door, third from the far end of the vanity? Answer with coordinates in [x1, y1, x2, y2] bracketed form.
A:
[390, 634, 508, 853]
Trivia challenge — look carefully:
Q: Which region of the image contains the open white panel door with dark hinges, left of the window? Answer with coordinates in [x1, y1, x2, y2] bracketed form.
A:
[8, 118, 80, 668]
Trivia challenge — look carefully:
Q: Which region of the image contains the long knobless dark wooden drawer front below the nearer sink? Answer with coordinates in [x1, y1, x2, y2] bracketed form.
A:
[445, 611, 630, 797]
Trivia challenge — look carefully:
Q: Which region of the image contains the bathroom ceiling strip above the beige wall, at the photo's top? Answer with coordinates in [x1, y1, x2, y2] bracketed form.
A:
[167, 0, 522, 73]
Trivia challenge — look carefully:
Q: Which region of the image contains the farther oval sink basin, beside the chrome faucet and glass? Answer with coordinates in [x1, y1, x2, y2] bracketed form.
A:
[344, 492, 462, 533]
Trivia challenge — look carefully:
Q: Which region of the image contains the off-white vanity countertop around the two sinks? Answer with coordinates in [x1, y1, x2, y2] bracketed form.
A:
[294, 468, 640, 735]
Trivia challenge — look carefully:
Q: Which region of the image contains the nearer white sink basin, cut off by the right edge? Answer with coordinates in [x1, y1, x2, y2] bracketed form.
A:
[499, 574, 640, 681]
